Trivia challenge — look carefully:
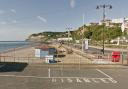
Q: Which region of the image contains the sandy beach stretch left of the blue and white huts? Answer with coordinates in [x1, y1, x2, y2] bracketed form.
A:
[0, 47, 42, 62]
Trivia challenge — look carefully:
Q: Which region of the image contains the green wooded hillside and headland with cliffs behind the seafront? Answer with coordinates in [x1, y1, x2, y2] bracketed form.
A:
[27, 25, 126, 42]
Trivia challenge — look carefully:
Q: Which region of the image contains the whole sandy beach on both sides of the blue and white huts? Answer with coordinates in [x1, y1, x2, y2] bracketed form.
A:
[0, 44, 91, 64]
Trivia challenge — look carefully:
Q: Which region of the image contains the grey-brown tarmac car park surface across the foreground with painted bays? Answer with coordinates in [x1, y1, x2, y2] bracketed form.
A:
[0, 63, 128, 89]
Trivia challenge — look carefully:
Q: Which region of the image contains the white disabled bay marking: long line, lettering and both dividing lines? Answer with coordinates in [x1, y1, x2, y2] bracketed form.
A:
[0, 68, 117, 84]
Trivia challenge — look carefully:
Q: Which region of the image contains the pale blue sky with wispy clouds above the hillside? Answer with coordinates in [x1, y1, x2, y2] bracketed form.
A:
[0, 0, 128, 41]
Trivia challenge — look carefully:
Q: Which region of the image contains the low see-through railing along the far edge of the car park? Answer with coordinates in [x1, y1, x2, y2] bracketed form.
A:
[0, 52, 128, 65]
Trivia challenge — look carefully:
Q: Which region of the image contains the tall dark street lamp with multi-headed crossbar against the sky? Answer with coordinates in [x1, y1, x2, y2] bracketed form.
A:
[96, 4, 112, 54]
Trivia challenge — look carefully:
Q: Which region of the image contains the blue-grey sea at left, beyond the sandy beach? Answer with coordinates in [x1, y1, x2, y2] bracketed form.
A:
[0, 41, 32, 52]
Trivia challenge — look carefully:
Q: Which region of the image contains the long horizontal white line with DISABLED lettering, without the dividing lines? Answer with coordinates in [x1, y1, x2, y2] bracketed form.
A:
[0, 75, 117, 83]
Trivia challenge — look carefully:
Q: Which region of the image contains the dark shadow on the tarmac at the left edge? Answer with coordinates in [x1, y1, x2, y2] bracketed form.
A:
[0, 62, 28, 72]
